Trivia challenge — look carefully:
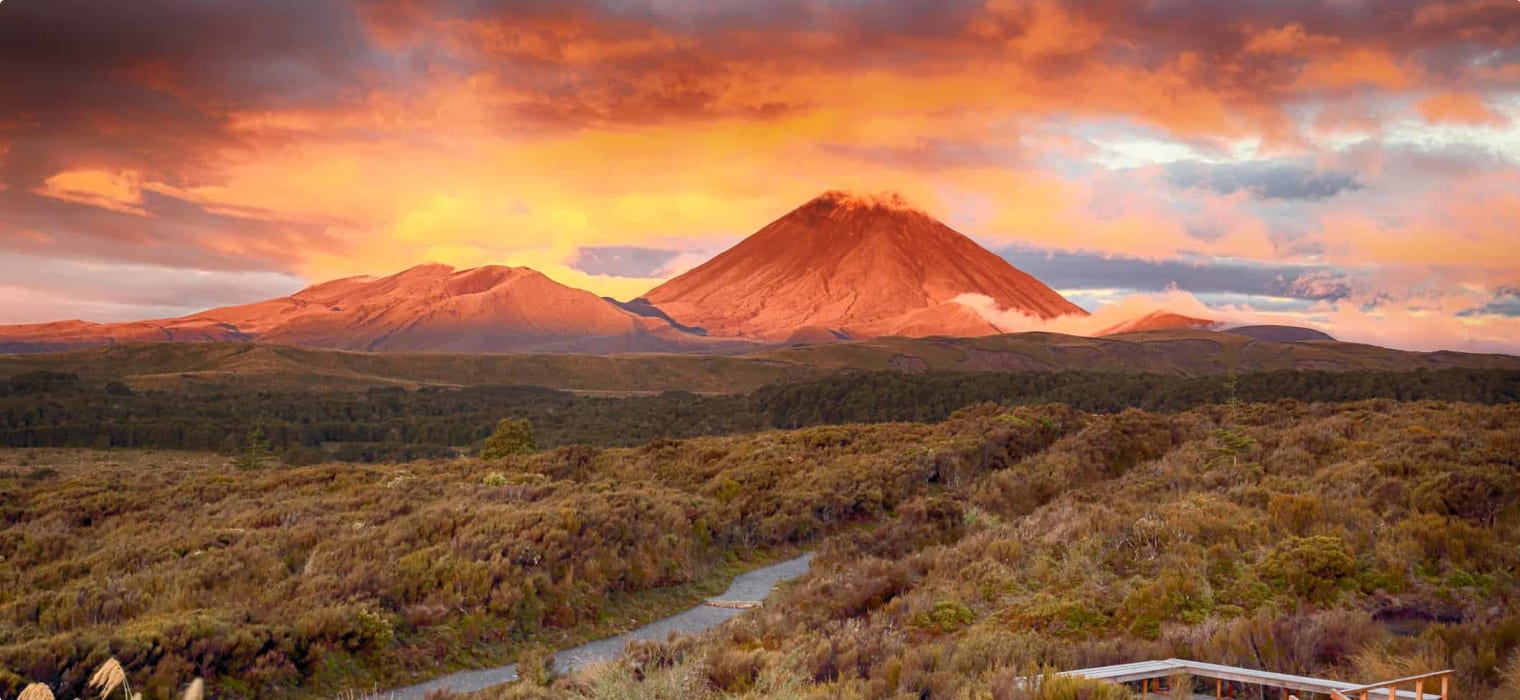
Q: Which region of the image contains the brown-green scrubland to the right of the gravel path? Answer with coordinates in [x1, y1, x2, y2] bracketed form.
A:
[437, 401, 1520, 700]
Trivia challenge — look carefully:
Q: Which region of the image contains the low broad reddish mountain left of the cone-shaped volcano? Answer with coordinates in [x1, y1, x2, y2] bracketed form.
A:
[0, 264, 717, 352]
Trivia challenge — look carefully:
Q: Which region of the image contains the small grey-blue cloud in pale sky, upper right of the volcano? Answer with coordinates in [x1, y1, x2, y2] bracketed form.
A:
[1166, 161, 1362, 200]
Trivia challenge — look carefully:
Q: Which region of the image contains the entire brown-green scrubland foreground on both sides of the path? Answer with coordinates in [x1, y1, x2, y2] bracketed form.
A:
[0, 392, 1520, 700]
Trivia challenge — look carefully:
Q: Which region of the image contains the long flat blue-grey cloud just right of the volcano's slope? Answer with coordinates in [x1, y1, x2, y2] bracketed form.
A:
[1000, 248, 1351, 301]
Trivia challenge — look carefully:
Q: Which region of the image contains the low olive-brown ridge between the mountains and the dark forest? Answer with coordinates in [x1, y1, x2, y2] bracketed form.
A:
[0, 331, 1520, 393]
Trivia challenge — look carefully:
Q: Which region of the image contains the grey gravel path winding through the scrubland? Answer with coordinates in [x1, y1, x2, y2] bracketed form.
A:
[365, 553, 813, 700]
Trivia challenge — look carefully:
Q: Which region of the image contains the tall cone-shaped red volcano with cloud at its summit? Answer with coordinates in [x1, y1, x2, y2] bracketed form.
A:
[640, 191, 1087, 342]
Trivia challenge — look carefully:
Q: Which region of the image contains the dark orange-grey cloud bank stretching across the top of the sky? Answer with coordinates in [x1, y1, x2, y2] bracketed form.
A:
[0, 0, 1520, 170]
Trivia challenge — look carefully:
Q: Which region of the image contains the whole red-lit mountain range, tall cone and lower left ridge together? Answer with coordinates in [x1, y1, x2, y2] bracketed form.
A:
[0, 191, 1085, 354]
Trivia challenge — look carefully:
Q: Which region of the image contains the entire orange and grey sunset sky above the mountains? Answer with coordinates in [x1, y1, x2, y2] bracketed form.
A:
[0, 0, 1520, 352]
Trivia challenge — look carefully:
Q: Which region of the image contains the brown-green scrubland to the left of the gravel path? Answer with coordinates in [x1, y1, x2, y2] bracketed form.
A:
[0, 400, 1079, 697]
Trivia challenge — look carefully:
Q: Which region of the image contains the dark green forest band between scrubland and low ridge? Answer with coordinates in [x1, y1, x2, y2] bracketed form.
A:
[0, 369, 1520, 465]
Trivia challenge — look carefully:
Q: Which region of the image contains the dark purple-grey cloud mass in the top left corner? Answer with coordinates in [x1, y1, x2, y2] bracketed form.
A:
[0, 0, 395, 187]
